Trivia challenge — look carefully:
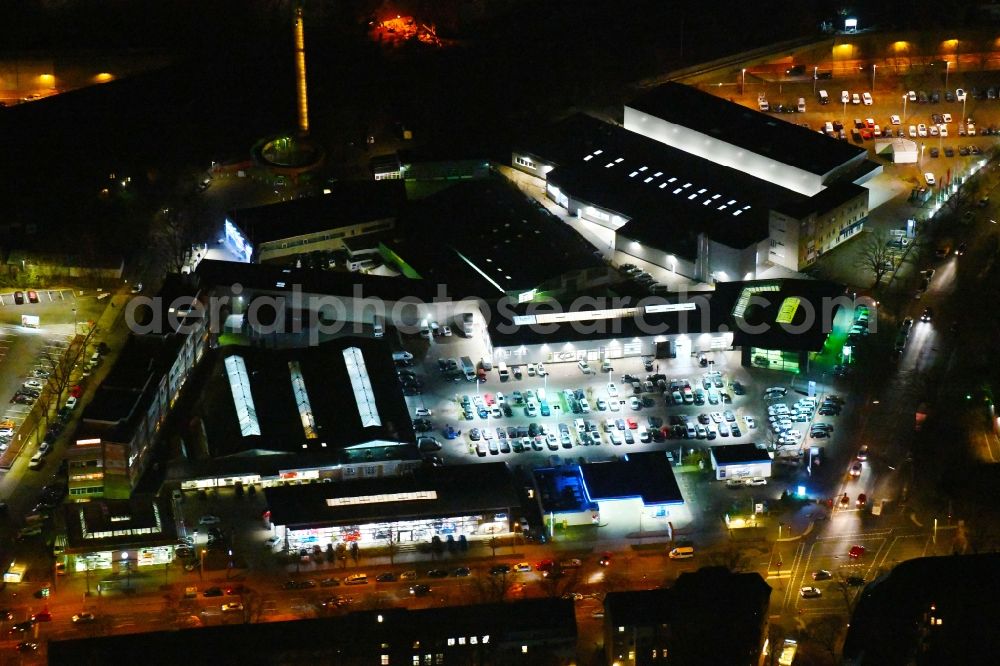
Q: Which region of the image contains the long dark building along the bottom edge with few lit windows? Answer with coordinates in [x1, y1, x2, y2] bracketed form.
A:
[48, 599, 577, 666]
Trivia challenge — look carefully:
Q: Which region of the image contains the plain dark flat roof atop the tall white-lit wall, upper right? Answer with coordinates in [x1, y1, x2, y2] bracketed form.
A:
[626, 82, 866, 176]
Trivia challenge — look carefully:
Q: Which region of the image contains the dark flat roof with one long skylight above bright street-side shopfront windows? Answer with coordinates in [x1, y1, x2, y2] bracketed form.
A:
[264, 462, 520, 529]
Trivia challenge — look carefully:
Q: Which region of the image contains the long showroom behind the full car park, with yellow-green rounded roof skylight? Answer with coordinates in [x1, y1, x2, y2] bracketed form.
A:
[487, 280, 851, 372]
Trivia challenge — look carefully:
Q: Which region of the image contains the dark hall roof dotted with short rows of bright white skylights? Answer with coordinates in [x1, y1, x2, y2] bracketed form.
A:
[532, 116, 806, 256]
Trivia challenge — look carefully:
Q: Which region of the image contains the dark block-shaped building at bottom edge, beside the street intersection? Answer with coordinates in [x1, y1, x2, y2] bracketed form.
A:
[604, 567, 771, 666]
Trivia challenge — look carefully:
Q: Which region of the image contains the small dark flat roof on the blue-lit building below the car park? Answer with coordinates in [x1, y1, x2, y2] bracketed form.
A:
[580, 451, 684, 506]
